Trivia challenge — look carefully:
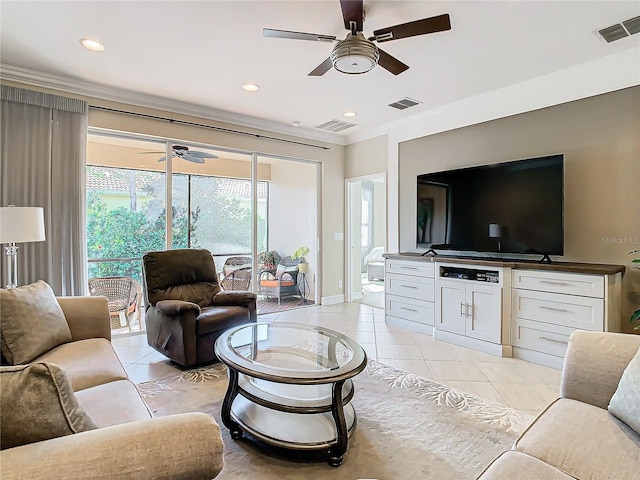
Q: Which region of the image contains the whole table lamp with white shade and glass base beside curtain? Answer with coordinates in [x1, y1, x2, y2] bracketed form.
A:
[0, 205, 45, 288]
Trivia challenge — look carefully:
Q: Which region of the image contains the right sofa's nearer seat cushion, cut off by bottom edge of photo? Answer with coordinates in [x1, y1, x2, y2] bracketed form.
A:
[478, 450, 573, 480]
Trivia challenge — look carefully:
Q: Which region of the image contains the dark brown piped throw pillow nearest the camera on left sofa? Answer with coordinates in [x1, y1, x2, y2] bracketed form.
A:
[0, 362, 96, 449]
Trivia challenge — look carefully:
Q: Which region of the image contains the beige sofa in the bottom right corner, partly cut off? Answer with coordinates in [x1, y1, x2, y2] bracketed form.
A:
[479, 331, 640, 480]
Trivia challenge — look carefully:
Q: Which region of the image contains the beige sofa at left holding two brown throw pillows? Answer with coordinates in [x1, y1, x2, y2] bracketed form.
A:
[0, 297, 223, 480]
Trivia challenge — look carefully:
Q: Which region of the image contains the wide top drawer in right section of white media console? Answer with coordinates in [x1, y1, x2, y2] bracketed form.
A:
[511, 269, 605, 298]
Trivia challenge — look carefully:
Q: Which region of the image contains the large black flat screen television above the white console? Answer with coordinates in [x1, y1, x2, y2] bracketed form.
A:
[416, 154, 564, 256]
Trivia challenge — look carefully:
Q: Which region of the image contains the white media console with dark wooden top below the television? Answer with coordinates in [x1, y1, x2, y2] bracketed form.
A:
[385, 254, 624, 368]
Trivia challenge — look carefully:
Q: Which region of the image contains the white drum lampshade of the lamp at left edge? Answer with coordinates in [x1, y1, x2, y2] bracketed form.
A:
[0, 207, 46, 243]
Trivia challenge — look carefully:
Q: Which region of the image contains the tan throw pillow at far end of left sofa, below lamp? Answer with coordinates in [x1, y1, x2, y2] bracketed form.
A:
[0, 280, 71, 365]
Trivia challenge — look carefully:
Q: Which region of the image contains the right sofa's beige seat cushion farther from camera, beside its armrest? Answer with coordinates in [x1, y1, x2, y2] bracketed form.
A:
[515, 398, 640, 480]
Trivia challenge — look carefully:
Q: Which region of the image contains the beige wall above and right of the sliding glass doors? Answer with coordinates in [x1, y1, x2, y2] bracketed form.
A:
[2, 81, 345, 298]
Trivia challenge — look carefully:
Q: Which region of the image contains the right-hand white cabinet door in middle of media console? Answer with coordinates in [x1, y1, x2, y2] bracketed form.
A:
[466, 284, 502, 343]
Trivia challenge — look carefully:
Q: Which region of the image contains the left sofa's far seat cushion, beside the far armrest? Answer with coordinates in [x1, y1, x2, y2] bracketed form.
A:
[38, 338, 128, 392]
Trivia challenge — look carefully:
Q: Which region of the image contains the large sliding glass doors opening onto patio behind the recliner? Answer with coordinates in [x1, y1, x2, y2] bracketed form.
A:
[86, 131, 320, 334]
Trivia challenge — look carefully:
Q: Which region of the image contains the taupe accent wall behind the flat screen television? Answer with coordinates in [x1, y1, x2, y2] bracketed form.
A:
[398, 87, 640, 331]
